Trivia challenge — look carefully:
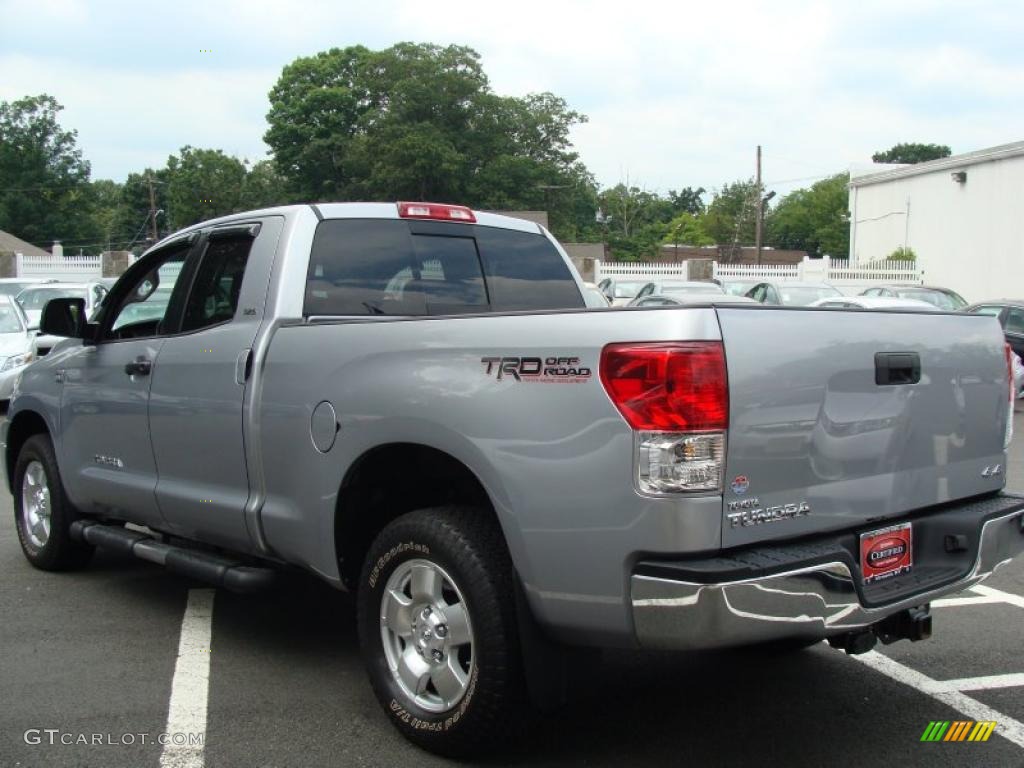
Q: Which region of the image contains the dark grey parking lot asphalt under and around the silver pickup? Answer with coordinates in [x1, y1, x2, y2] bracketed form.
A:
[0, 412, 1024, 768]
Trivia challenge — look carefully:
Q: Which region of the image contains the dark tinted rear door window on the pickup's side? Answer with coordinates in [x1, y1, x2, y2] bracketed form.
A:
[181, 234, 253, 332]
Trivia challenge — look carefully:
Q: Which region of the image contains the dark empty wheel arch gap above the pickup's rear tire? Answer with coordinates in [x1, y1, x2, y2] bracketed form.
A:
[334, 442, 508, 587]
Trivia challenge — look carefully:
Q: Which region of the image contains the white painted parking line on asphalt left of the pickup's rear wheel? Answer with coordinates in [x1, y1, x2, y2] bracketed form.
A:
[160, 589, 216, 768]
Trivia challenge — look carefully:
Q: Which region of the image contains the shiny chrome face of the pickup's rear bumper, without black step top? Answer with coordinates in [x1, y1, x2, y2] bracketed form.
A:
[631, 498, 1024, 650]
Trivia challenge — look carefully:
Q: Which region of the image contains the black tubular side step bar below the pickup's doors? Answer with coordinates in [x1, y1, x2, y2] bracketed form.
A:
[71, 520, 276, 593]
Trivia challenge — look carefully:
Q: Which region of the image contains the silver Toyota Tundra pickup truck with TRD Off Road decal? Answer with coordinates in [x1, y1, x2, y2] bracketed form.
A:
[3, 203, 1024, 754]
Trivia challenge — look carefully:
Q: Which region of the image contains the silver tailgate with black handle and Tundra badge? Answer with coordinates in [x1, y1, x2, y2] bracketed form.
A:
[717, 307, 1009, 547]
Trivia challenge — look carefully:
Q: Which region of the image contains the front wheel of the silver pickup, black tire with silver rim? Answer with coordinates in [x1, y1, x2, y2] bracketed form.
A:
[13, 434, 93, 570]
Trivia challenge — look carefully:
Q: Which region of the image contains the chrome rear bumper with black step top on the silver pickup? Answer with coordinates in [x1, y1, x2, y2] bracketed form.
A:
[631, 495, 1024, 650]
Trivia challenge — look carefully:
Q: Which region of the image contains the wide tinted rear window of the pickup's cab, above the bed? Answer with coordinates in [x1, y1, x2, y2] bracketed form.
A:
[304, 219, 584, 315]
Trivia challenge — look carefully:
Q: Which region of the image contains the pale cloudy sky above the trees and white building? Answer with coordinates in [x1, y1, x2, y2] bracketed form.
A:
[0, 0, 1024, 198]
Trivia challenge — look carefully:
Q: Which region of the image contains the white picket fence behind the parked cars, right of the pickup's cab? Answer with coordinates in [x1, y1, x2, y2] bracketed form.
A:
[594, 259, 924, 288]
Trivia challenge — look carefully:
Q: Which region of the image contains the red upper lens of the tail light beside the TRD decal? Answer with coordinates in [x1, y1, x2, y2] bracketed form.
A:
[601, 341, 729, 432]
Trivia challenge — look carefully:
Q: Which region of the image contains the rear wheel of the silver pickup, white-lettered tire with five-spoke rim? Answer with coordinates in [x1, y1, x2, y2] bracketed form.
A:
[357, 507, 527, 757]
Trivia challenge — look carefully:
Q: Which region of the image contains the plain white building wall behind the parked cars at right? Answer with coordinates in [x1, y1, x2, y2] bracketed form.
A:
[850, 155, 1024, 302]
